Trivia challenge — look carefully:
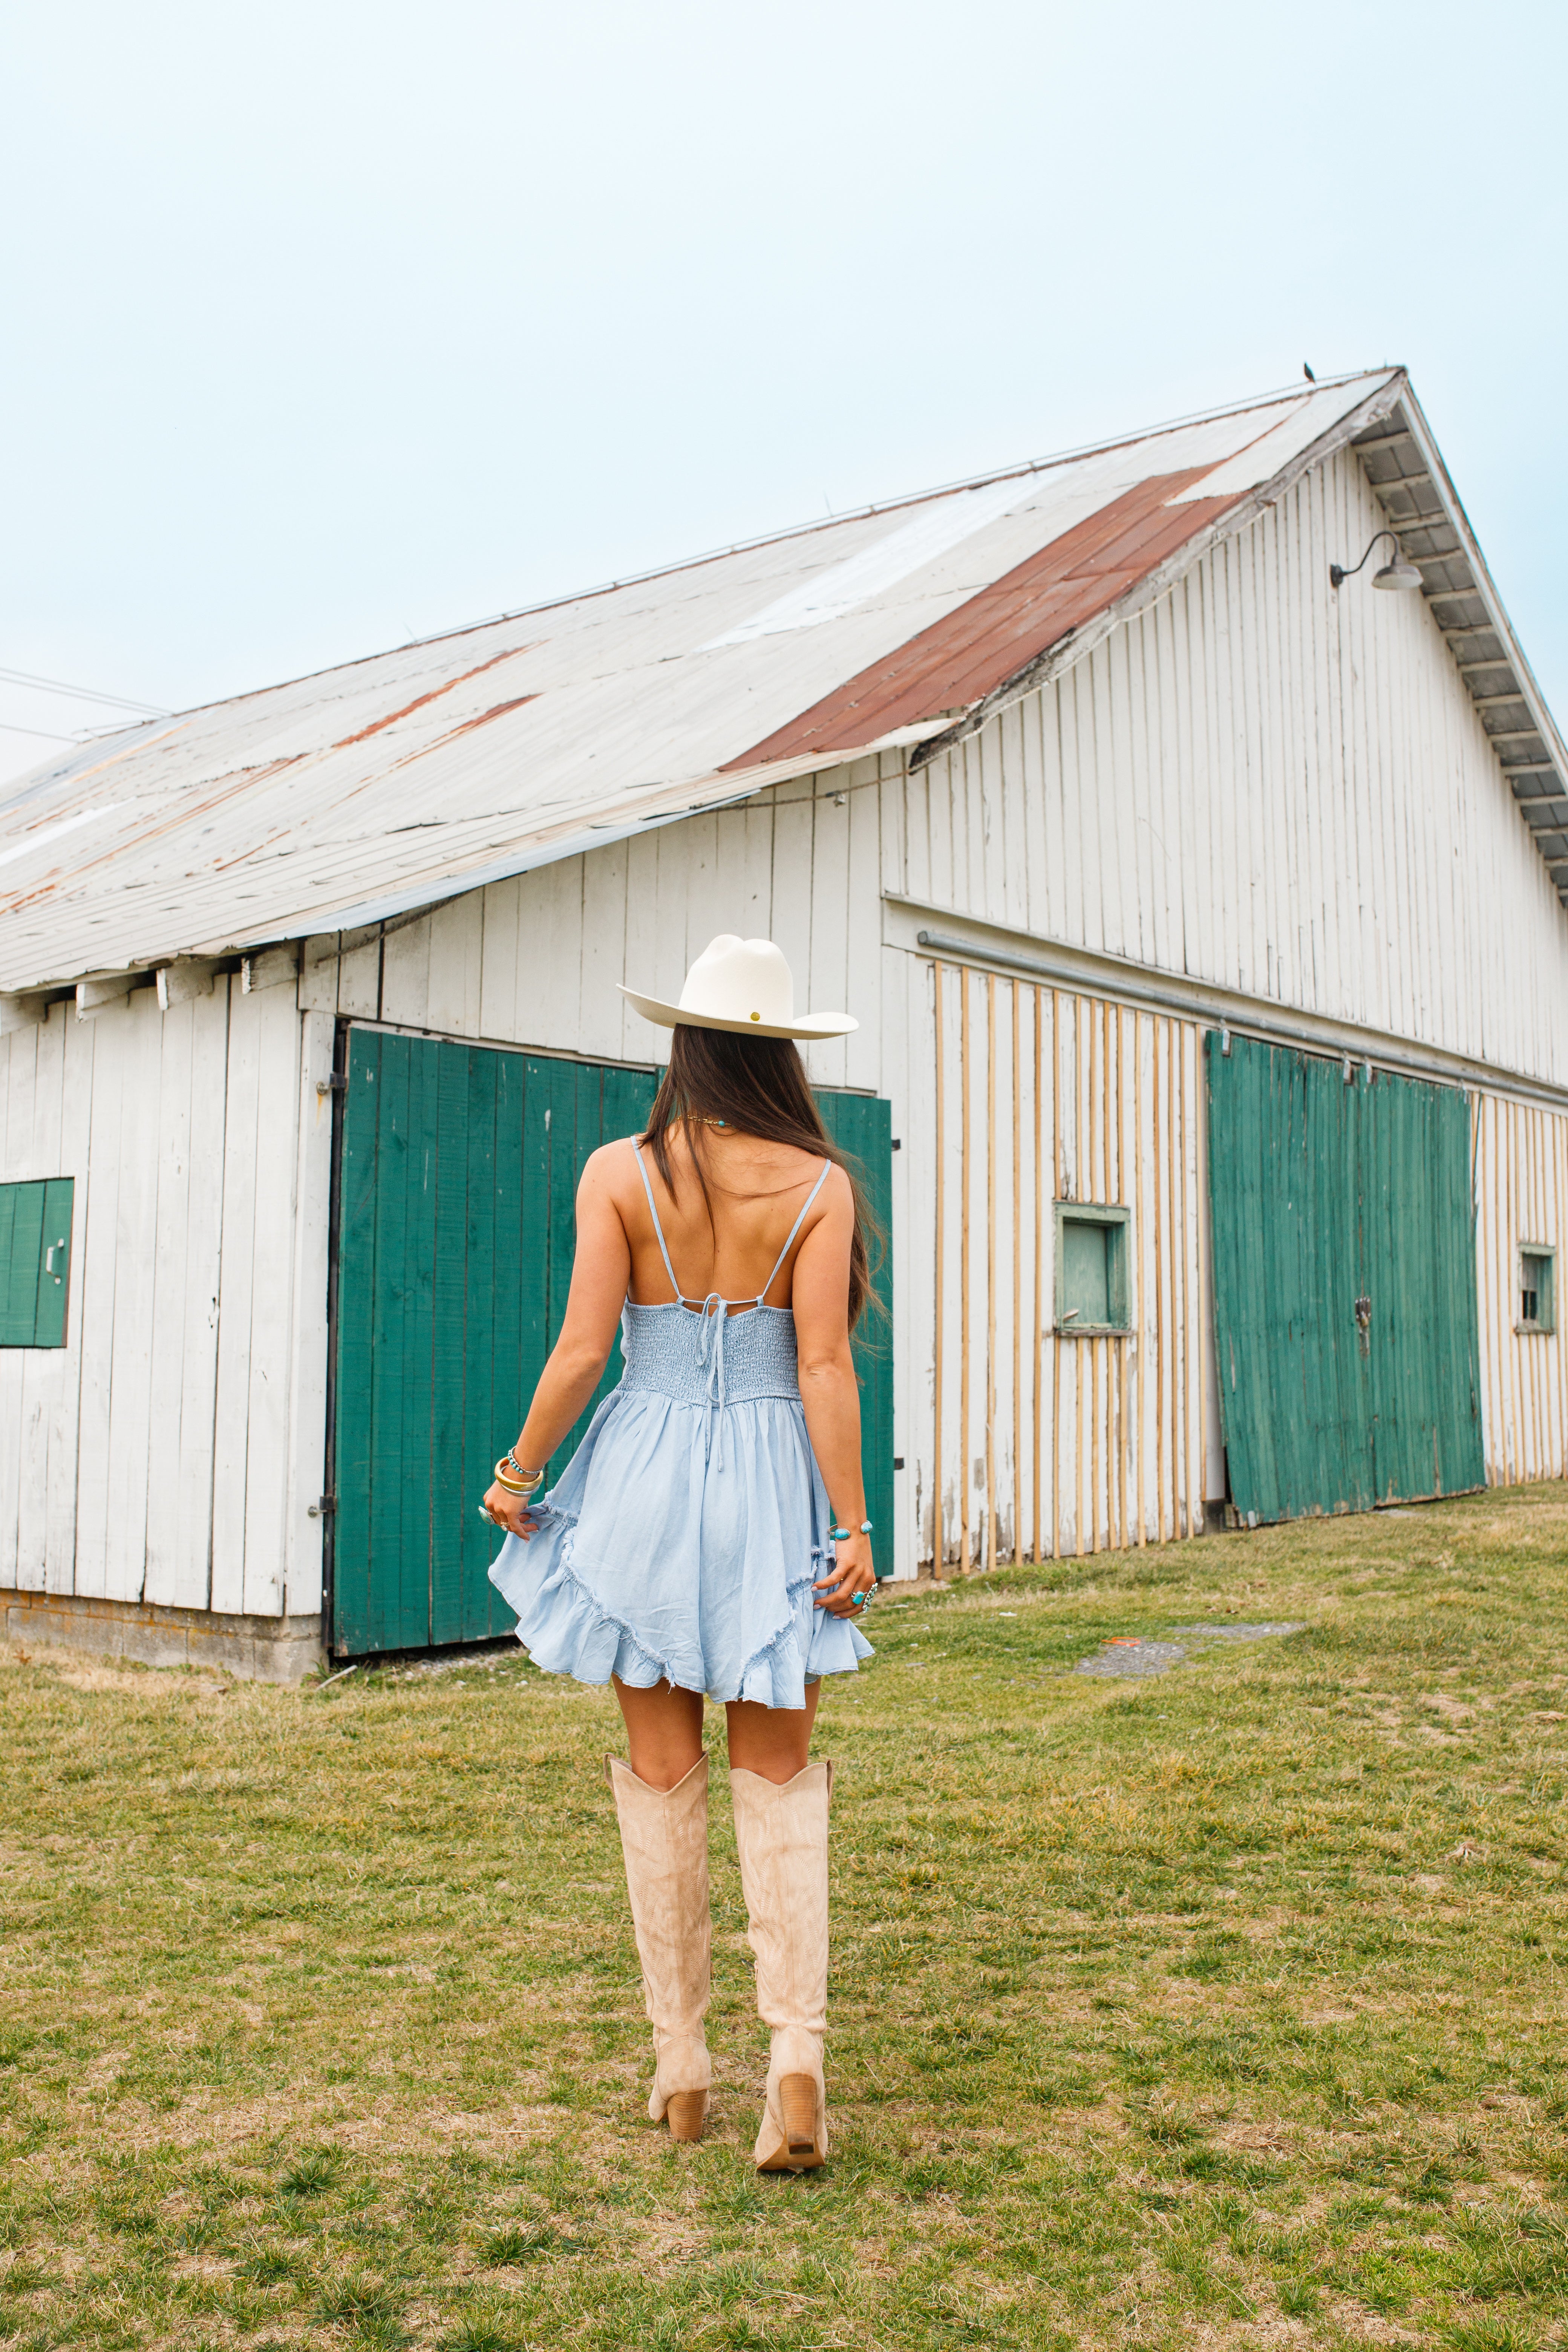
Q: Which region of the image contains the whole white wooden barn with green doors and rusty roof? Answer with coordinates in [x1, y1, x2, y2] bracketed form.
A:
[0, 369, 1568, 1675]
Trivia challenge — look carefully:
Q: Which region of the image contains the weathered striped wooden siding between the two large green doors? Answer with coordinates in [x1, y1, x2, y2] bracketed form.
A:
[922, 964, 1208, 1569]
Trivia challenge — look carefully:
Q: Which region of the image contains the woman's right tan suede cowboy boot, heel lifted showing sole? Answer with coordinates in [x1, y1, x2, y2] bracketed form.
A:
[729, 1762, 832, 2173]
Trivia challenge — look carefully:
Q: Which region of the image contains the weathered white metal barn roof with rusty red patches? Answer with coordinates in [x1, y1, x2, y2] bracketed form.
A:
[0, 369, 1561, 992]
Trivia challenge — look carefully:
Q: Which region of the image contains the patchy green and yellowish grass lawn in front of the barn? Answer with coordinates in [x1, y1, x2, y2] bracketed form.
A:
[0, 1487, 1568, 2352]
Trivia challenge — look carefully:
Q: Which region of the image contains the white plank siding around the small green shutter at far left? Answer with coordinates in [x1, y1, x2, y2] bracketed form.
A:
[0, 978, 331, 1616]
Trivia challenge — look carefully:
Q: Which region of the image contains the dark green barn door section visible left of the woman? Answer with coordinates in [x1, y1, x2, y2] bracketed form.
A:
[331, 1028, 656, 1656]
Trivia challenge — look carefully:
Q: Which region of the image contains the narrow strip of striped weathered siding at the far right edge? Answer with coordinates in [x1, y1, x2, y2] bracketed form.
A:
[1472, 1094, 1568, 1487]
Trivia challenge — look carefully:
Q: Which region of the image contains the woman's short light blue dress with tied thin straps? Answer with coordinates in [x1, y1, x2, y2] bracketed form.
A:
[489, 1141, 872, 1707]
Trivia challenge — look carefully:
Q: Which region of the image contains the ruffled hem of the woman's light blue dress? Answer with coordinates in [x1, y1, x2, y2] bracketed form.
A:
[489, 1503, 874, 1710]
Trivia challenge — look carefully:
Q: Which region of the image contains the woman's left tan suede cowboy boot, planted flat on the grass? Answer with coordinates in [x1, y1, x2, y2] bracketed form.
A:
[604, 1757, 712, 2140]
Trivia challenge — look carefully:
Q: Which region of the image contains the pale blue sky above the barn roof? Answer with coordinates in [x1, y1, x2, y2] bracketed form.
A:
[0, 0, 1568, 772]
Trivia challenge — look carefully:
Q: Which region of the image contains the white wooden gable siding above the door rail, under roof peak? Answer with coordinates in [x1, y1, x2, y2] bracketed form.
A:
[902, 452, 1568, 1084]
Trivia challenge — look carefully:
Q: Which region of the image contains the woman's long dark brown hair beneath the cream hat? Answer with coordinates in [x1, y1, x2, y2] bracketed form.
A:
[642, 1021, 882, 1331]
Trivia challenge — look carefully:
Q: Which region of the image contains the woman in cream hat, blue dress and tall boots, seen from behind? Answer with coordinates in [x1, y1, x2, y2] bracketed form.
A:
[482, 934, 874, 2171]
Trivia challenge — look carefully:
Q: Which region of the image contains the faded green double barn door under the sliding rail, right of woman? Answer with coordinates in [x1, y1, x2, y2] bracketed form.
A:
[1206, 1032, 1483, 1519]
